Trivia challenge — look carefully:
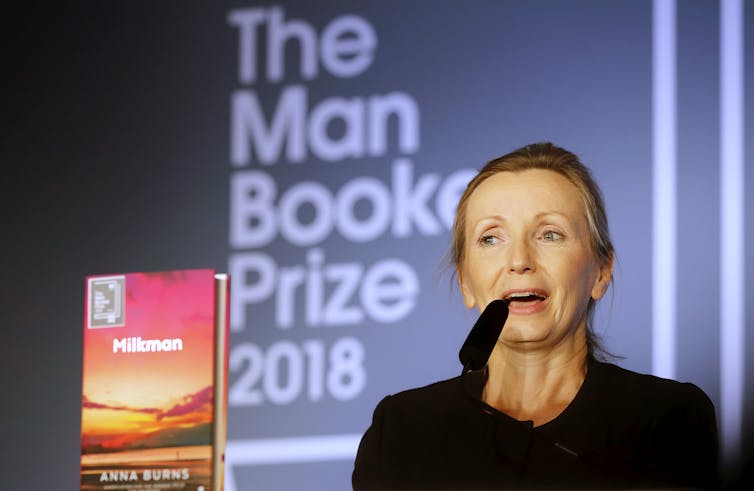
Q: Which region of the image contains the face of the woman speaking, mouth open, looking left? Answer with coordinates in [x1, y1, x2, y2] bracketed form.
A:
[458, 169, 612, 348]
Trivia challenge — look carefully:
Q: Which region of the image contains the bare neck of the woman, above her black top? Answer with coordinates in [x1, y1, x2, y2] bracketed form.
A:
[482, 336, 587, 426]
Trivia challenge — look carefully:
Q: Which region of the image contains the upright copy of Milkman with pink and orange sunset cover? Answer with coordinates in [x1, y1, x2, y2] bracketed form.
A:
[80, 269, 230, 491]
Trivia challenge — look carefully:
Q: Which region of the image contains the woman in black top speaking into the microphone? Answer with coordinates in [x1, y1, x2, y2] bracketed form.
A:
[352, 143, 717, 490]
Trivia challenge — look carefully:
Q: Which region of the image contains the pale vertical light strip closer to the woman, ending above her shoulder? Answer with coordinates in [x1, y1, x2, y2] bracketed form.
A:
[652, 0, 676, 378]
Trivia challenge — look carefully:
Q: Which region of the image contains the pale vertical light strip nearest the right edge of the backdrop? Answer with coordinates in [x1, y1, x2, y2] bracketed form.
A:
[720, 0, 745, 464]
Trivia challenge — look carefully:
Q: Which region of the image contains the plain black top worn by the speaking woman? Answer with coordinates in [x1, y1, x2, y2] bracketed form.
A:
[352, 361, 717, 490]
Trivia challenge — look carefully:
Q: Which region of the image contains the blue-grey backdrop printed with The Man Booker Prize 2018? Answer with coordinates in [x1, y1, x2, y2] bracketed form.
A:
[0, 0, 754, 491]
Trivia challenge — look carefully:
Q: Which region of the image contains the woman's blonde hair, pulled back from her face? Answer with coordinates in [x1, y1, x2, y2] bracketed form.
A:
[449, 142, 615, 357]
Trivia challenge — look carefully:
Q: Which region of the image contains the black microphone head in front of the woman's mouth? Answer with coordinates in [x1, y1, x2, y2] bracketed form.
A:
[458, 300, 508, 370]
